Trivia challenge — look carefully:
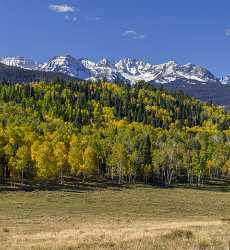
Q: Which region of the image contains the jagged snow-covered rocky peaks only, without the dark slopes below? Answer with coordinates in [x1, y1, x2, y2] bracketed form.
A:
[0, 55, 222, 84]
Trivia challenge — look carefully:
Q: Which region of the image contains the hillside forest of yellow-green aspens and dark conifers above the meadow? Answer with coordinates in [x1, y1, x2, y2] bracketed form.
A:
[0, 81, 230, 186]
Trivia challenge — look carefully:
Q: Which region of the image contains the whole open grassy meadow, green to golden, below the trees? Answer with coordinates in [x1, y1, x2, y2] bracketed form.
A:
[0, 183, 230, 250]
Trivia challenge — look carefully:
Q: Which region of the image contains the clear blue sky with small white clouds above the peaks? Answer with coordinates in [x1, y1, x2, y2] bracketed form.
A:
[0, 0, 230, 76]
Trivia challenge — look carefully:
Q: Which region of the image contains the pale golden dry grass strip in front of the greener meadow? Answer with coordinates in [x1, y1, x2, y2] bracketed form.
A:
[0, 221, 230, 250]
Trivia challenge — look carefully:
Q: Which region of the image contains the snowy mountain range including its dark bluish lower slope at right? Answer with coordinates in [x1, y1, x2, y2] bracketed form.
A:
[0, 55, 230, 106]
